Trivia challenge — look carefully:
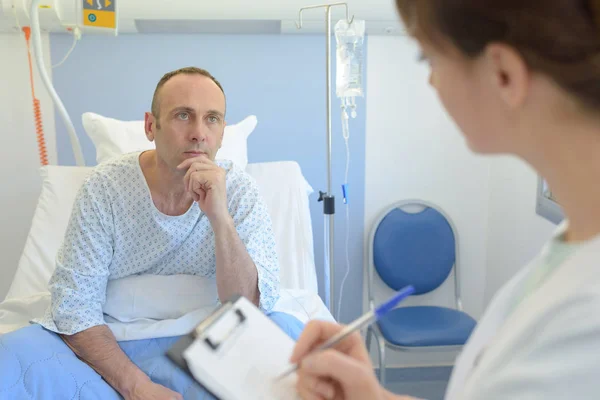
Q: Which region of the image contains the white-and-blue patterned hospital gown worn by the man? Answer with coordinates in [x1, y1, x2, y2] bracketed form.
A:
[35, 153, 280, 335]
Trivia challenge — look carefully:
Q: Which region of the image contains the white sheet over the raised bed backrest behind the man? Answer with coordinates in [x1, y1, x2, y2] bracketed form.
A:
[0, 161, 333, 333]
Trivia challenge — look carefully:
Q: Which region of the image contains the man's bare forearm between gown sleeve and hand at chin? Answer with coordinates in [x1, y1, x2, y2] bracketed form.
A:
[212, 216, 260, 306]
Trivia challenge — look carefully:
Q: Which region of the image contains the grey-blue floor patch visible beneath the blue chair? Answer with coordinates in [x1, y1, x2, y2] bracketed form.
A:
[386, 367, 452, 400]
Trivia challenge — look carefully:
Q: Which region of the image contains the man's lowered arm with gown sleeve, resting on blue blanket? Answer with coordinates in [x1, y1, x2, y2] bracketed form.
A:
[40, 175, 181, 400]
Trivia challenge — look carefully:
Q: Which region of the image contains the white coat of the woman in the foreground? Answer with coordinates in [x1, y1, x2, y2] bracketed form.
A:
[445, 224, 600, 400]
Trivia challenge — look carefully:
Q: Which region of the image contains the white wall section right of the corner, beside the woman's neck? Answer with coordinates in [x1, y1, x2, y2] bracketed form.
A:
[485, 157, 556, 305]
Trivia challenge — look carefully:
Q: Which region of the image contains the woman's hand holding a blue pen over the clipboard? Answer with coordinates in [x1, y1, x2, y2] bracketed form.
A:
[290, 321, 386, 400]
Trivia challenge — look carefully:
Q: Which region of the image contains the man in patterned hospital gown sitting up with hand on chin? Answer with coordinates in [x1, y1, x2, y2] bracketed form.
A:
[28, 68, 296, 399]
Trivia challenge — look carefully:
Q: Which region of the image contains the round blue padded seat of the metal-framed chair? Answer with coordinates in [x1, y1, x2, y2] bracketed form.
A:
[378, 306, 476, 347]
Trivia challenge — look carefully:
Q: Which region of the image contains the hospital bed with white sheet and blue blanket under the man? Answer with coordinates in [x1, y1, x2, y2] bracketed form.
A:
[0, 135, 334, 399]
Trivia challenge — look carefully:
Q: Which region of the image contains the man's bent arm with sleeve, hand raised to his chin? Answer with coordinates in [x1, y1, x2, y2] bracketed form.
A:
[178, 156, 279, 312]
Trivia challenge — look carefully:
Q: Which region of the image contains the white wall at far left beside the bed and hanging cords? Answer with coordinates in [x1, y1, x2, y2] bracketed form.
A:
[0, 34, 56, 299]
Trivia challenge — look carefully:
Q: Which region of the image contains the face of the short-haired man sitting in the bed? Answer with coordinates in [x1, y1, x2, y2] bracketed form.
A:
[146, 74, 225, 169]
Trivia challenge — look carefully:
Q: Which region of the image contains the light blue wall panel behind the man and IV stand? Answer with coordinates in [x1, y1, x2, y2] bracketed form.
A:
[51, 34, 366, 322]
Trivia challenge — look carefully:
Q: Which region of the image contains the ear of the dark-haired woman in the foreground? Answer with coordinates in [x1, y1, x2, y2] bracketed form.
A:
[483, 43, 531, 109]
